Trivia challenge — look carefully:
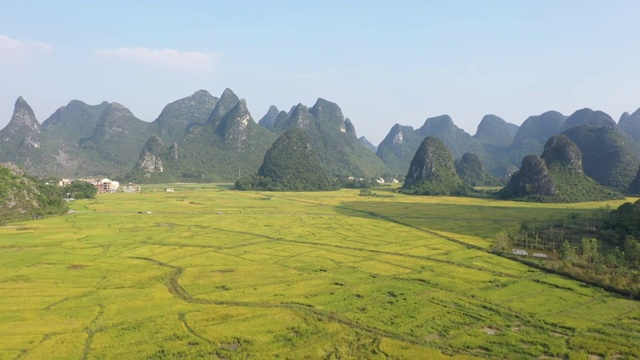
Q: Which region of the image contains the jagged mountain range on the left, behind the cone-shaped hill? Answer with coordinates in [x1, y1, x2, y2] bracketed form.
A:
[0, 89, 389, 182]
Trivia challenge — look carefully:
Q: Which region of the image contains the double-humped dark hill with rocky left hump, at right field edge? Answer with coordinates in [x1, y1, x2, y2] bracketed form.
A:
[499, 135, 623, 202]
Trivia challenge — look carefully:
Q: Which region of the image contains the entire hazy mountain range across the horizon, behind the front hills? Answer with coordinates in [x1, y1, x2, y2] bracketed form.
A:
[0, 89, 640, 190]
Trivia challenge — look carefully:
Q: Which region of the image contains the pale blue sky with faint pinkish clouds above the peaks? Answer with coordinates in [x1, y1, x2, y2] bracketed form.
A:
[0, 0, 640, 144]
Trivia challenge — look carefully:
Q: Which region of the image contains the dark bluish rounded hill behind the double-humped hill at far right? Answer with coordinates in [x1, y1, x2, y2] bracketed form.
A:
[563, 125, 638, 191]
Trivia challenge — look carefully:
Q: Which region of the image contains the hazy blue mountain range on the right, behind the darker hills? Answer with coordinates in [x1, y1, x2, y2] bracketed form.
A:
[377, 109, 640, 181]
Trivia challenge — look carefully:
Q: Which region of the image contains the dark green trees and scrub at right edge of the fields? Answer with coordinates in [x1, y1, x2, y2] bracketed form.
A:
[494, 200, 640, 297]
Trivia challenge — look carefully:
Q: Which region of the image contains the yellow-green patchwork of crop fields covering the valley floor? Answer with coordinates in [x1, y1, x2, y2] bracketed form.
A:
[0, 185, 640, 359]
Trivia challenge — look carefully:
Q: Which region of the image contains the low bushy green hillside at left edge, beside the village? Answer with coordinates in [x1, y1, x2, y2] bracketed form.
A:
[0, 163, 67, 224]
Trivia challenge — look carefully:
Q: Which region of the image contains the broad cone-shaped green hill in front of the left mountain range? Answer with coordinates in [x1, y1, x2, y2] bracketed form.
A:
[236, 128, 337, 191]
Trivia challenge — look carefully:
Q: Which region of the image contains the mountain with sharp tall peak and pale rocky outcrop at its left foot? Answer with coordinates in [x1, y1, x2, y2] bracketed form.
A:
[127, 89, 276, 183]
